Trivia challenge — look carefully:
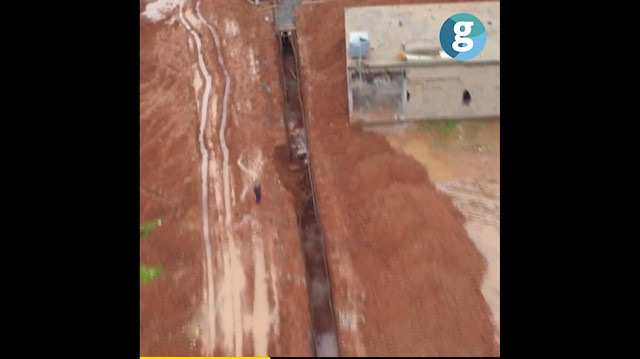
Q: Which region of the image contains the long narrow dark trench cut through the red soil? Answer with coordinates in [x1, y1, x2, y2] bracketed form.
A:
[274, 32, 338, 357]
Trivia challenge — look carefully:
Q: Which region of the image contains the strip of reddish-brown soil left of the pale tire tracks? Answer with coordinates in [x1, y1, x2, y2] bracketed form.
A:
[140, 7, 203, 355]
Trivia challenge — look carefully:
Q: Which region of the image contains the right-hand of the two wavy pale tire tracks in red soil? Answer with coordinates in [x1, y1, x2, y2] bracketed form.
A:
[195, 1, 244, 356]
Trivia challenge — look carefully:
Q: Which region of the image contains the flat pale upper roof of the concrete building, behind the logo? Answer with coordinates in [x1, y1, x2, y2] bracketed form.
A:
[344, 1, 500, 67]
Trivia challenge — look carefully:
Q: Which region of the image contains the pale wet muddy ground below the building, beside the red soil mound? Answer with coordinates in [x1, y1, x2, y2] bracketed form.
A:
[380, 119, 500, 345]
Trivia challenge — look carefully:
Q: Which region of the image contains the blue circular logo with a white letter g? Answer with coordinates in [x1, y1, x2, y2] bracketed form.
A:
[440, 13, 487, 61]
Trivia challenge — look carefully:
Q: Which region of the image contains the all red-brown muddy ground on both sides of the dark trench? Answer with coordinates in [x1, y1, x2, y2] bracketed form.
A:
[140, 0, 499, 356]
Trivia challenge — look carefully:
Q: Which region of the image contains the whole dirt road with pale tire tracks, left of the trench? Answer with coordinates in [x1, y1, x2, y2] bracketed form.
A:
[140, 0, 311, 356]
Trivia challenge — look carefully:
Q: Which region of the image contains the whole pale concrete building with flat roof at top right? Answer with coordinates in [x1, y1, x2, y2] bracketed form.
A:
[345, 2, 500, 124]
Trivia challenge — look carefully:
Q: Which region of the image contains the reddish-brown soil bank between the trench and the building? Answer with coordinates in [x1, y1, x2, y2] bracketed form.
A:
[296, 0, 499, 356]
